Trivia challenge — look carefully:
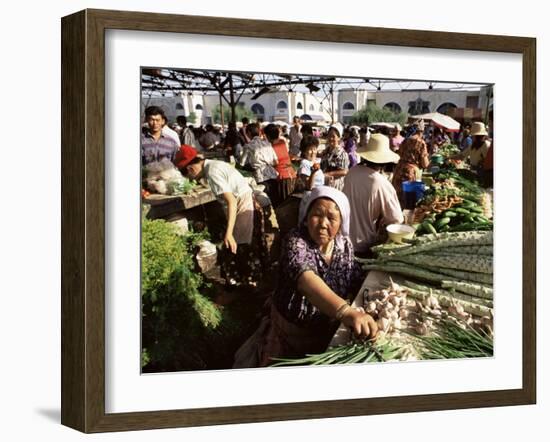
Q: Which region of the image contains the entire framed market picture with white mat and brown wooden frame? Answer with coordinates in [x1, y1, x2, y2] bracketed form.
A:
[61, 10, 536, 433]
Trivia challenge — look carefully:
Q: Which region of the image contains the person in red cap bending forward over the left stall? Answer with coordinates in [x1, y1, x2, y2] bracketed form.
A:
[174, 145, 267, 294]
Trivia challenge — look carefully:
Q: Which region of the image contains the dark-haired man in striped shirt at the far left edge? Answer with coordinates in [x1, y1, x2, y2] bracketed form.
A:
[141, 106, 180, 165]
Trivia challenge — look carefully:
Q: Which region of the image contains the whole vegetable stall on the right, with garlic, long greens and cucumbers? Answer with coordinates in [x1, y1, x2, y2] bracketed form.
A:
[276, 164, 493, 365]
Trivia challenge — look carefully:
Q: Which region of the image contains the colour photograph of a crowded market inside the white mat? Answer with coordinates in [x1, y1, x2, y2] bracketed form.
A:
[140, 67, 494, 373]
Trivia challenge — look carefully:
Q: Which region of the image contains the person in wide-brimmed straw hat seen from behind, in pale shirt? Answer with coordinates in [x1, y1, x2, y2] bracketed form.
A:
[344, 134, 404, 256]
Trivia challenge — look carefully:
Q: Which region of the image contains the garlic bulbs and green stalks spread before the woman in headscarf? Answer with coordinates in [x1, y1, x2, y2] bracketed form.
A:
[271, 279, 493, 367]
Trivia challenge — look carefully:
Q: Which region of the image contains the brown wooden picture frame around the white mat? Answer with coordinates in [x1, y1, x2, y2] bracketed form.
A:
[61, 10, 536, 433]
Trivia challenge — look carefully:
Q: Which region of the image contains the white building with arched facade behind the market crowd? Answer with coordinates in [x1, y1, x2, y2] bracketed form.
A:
[141, 88, 492, 125]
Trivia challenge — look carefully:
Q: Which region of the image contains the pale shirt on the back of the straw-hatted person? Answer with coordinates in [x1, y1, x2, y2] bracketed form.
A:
[343, 165, 403, 252]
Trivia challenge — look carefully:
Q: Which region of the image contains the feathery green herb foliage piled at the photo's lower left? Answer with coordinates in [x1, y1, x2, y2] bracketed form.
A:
[141, 219, 222, 371]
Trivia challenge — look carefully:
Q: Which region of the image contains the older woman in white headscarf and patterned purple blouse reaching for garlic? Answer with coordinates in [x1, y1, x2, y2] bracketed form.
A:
[234, 186, 378, 368]
